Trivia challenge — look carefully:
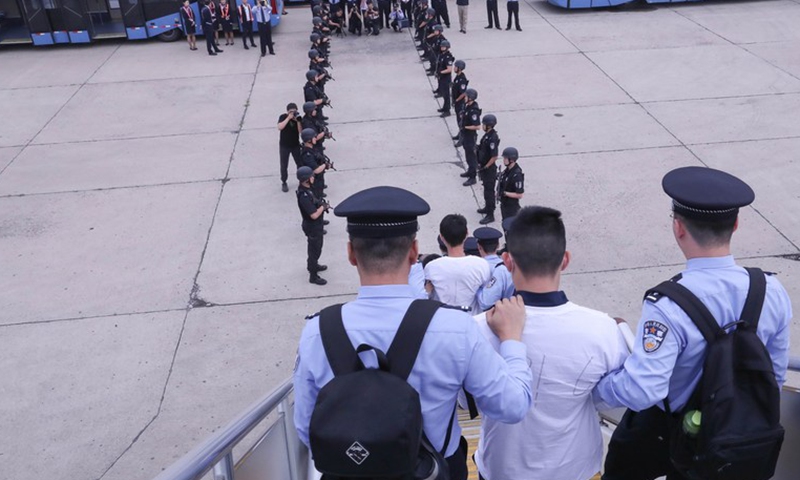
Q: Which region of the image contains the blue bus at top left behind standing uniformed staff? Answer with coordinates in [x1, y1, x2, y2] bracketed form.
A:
[0, 0, 283, 46]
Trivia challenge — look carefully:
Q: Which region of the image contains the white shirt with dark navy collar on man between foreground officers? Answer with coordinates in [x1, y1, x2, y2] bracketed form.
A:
[475, 292, 628, 480]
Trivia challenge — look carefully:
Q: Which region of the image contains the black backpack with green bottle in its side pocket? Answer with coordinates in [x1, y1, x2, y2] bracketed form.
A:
[646, 268, 784, 480]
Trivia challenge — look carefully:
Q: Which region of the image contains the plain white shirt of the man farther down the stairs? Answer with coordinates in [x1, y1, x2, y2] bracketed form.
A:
[425, 255, 492, 314]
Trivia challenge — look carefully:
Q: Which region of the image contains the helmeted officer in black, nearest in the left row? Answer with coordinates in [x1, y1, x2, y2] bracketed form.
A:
[297, 166, 329, 285]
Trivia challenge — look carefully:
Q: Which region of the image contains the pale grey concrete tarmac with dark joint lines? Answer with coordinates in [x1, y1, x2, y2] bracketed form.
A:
[0, 0, 800, 480]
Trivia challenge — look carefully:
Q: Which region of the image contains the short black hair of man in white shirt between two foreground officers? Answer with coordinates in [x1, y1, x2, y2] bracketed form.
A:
[506, 206, 567, 276]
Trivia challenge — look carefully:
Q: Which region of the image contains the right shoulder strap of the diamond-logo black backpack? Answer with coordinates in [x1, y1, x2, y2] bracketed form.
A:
[386, 300, 441, 380]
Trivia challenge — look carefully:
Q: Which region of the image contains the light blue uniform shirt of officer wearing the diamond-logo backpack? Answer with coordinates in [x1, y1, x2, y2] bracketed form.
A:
[294, 285, 532, 456]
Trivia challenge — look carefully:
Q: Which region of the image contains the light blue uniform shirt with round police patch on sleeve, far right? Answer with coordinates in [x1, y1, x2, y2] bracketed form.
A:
[594, 256, 792, 412]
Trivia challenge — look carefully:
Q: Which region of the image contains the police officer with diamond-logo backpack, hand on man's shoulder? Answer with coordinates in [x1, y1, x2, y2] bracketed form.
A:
[294, 187, 532, 480]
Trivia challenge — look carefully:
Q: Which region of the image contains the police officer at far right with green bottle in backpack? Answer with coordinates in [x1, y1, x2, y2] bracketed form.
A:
[595, 167, 792, 480]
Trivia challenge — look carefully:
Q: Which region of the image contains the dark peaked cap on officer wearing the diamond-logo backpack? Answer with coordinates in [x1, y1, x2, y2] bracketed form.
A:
[333, 187, 431, 238]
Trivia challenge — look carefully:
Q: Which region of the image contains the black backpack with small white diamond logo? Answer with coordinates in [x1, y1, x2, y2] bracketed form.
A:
[309, 300, 455, 480]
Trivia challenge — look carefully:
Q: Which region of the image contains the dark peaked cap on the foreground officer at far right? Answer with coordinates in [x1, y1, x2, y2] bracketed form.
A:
[661, 167, 756, 221]
